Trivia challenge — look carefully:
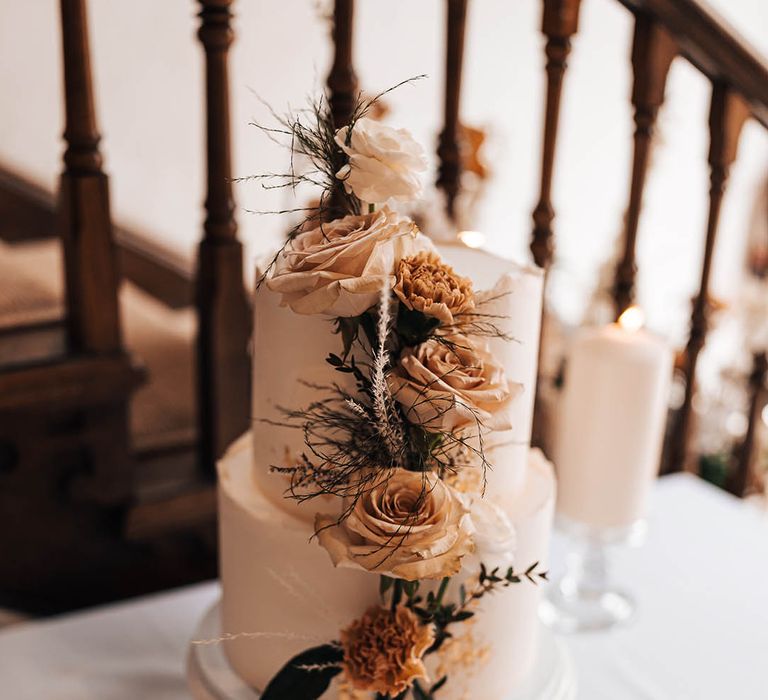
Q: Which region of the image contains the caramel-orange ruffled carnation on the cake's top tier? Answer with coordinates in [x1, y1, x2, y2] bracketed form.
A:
[394, 250, 475, 323]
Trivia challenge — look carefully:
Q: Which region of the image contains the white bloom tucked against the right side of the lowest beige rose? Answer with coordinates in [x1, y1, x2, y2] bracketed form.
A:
[464, 494, 517, 572]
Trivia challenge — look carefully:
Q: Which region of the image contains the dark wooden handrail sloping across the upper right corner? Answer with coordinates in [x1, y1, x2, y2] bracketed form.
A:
[619, 0, 768, 128]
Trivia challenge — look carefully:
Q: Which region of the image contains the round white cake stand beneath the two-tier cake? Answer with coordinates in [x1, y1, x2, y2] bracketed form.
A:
[187, 603, 576, 700]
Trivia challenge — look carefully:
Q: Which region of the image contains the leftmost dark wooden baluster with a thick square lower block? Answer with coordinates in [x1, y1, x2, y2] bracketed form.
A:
[59, 0, 121, 353]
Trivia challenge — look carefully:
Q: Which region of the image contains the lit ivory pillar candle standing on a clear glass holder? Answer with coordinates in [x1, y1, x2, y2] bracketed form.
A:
[555, 307, 672, 528]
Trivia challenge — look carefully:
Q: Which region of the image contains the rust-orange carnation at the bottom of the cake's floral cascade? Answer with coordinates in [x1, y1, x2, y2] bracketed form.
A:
[341, 605, 435, 696]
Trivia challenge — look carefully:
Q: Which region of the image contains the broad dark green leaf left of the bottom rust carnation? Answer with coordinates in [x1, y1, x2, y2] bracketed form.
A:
[261, 644, 344, 700]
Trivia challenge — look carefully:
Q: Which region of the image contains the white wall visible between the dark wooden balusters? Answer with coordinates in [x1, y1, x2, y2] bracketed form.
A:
[0, 0, 768, 337]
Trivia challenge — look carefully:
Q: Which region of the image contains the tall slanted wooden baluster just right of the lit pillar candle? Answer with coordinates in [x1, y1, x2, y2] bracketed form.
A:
[662, 83, 749, 473]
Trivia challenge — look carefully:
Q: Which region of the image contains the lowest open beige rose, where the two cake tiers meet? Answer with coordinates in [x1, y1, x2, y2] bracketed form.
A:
[315, 469, 473, 581]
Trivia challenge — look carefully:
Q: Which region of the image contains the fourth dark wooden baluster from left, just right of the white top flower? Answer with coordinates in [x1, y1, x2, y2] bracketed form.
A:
[437, 0, 467, 220]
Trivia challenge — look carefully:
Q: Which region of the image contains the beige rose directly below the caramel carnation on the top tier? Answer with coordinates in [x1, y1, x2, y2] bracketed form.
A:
[388, 334, 522, 434]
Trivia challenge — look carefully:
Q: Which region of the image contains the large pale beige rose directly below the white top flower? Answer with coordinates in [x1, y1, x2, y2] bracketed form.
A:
[267, 207, 430, 316]
